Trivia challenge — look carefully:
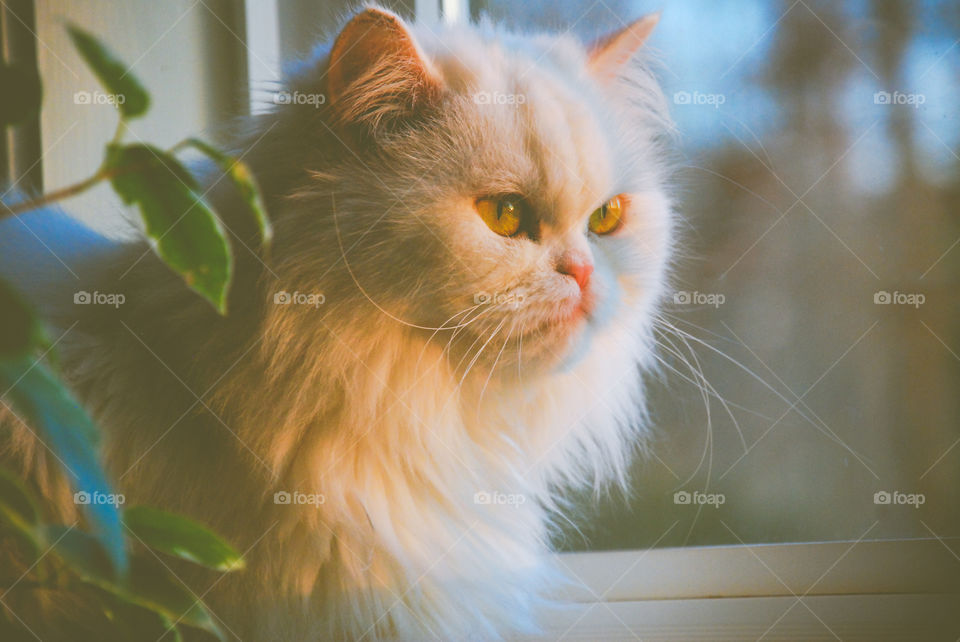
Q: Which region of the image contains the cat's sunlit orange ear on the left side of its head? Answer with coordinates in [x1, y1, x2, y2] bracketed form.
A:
[326, 8, 441, 127]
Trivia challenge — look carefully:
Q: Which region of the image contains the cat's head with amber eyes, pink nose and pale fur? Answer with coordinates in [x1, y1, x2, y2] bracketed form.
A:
[288, 7, 671, 371]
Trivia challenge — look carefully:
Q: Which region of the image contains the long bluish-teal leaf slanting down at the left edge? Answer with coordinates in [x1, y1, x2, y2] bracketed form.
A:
[0, 357, 127, 572]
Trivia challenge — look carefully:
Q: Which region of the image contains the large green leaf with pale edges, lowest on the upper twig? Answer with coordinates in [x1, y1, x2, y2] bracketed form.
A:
[106, 145, 233, 314]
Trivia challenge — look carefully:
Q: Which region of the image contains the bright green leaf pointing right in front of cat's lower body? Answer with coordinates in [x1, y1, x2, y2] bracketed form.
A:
[122, 506, 244, 571]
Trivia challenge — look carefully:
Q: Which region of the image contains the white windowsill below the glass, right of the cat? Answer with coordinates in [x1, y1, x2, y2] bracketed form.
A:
[517, 539, 960, 641]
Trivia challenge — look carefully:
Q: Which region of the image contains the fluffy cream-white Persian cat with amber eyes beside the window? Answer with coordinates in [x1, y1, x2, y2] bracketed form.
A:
[0, 8, 673, 642]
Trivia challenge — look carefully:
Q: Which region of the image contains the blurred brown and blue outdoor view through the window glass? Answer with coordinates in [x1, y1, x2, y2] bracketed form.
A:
[474, 0, 960, 548]
